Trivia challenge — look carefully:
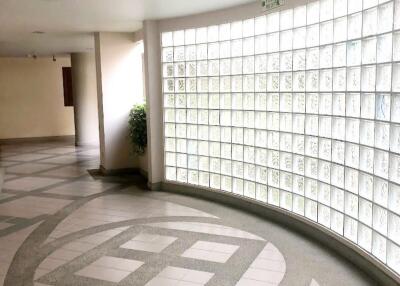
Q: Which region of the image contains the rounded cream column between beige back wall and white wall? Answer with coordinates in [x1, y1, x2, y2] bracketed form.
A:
[71, 53, 99, 146]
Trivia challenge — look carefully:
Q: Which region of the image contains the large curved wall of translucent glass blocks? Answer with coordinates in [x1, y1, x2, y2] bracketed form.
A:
[161, 0, 400, 274]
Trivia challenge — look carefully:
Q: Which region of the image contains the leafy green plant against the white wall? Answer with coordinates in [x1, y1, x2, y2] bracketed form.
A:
[128, 104, 147, 155]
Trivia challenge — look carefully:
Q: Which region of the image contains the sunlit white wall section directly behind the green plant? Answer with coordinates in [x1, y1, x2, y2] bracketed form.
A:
[95, 32, 145, 171]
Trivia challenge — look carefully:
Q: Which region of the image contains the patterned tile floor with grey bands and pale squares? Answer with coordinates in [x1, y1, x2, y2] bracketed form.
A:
[0, 143, 375, 286]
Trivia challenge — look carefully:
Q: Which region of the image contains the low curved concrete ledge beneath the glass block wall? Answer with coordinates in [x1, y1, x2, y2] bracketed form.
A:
[159, 182, 400, 286]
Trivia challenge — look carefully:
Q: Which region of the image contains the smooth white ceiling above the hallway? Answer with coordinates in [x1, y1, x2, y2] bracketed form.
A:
[0, 0, 255, 56]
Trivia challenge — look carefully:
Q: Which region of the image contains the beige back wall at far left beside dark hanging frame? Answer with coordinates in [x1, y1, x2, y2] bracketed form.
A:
[0, 58, 74, 139]
